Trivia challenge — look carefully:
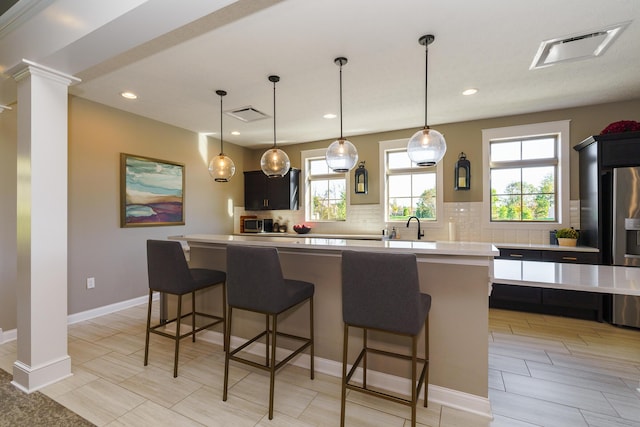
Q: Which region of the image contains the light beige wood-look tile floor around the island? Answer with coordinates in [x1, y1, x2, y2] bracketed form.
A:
[0, 305, 640, 427]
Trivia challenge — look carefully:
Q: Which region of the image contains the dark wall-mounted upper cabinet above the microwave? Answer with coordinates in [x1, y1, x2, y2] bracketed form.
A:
[244, 168, 300, 211]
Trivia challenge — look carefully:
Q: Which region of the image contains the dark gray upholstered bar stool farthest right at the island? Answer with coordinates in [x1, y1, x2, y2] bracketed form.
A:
[340, 251, 431, 426]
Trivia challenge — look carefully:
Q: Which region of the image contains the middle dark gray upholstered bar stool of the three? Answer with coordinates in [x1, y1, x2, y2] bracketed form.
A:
[222, 245, 315, 420]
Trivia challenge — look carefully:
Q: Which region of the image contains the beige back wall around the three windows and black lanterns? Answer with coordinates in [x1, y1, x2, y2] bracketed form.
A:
[248, 100, 640, 204]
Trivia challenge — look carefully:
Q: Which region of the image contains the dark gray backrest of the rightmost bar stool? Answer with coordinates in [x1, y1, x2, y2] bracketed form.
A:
[342, 251, 424, 334]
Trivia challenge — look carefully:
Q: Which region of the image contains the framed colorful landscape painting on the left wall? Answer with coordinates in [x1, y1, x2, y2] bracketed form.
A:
[120, 153, 185, 228]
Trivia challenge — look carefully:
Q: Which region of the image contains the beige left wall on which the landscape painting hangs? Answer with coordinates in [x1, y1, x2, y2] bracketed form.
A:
[67, 97, 244, 314]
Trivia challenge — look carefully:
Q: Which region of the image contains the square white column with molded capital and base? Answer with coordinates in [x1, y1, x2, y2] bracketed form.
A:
[12, 60, 77, 392]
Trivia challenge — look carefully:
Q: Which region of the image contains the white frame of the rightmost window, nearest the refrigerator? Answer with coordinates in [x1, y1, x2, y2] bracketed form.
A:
[482, 120, 571, 230]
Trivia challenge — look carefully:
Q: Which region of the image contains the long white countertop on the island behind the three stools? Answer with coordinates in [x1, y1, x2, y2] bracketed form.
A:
[171, 234, 500, 258]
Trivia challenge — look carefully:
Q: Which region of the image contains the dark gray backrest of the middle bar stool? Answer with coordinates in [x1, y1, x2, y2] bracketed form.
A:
[227, 245, 286, 311]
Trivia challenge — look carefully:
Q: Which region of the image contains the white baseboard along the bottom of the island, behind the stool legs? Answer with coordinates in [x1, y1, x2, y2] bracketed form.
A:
[198, 330, 493, 419]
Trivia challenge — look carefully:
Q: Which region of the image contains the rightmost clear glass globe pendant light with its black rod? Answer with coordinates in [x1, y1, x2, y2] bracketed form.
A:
[407, 34, 447, 166]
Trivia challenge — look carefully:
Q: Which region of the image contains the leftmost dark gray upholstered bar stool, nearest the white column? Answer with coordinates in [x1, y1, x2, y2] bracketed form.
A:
[144, 240, 227, 378]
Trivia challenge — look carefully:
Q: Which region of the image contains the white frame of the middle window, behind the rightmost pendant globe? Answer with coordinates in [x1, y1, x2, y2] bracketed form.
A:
[378, 138, 446, 228]
